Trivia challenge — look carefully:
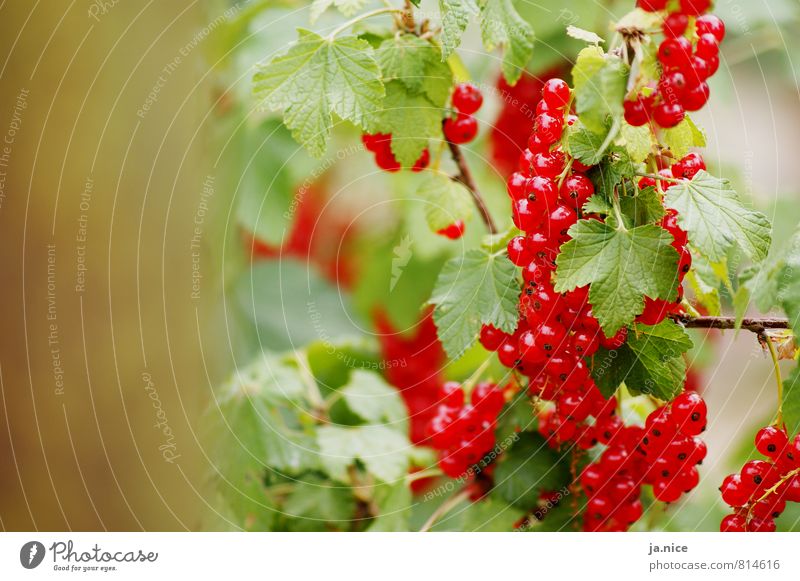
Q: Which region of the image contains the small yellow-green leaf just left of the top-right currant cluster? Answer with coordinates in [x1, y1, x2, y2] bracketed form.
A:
[573, 51, 630, 133]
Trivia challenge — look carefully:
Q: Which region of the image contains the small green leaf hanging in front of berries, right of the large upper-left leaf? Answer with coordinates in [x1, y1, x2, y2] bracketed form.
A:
[374, 81, 442, 167]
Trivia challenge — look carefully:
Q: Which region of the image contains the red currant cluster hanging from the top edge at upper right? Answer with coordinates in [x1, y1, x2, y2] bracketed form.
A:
[625, 0, 725, 128]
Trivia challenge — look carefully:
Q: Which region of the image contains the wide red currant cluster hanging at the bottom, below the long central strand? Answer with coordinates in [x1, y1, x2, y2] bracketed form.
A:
[580, 391, 707, 531]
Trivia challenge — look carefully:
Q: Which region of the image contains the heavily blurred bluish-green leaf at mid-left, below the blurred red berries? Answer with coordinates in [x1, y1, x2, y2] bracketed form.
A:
[235, 258, 363, 351]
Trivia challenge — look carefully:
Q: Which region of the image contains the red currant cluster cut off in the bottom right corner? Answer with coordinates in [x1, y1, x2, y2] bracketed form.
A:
[720, 426, 800, 532]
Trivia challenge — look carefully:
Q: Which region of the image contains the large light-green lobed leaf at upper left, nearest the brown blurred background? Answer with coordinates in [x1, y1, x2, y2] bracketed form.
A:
[253, 28, 384, 157]
